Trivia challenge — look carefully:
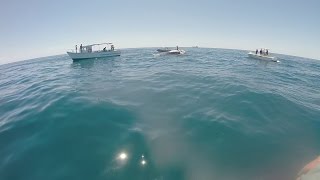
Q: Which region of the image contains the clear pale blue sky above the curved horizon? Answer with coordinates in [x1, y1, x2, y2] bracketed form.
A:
[0, 0, 320, 64]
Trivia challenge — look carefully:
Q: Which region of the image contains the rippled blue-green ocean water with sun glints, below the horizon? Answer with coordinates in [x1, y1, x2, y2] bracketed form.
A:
[0, 48, 320, 180]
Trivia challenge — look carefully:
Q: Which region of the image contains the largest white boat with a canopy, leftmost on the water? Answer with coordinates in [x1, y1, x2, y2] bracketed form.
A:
[67, 43, 121, 61]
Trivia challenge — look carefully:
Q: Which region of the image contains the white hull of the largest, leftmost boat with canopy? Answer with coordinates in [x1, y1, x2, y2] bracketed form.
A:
[67, 51, 121, 60]
